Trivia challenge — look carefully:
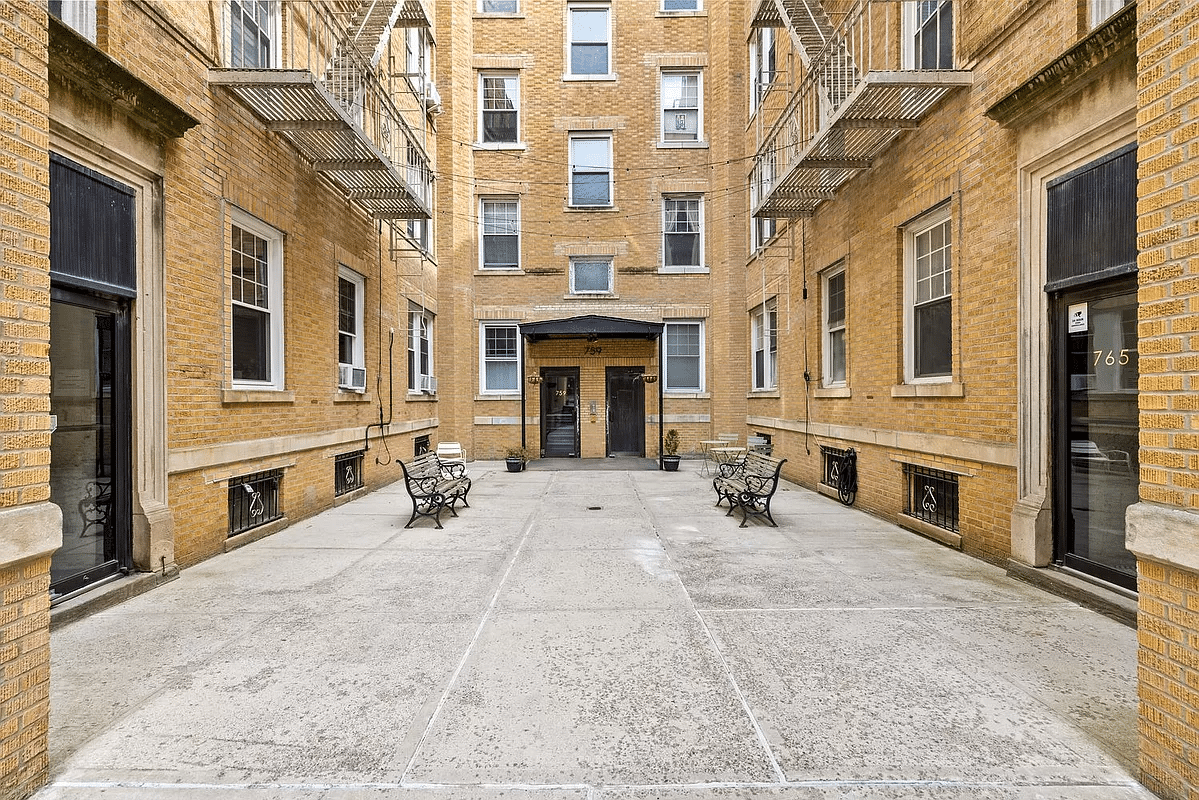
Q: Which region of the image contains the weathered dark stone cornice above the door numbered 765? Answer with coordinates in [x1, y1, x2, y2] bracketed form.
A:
[987, 4, 1137, 127]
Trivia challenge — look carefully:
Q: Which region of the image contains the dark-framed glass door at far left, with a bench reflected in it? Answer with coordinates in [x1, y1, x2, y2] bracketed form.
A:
[50, 289, 132, 599]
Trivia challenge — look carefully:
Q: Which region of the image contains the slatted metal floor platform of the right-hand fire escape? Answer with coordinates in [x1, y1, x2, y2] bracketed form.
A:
[753, 69, 972, 217]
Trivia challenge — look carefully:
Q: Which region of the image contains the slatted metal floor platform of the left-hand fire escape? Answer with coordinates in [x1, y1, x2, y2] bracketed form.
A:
[209, 70, 432, 219]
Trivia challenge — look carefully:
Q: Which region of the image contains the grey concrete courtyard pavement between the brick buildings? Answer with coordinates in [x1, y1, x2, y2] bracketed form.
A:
[36, 462, 1153, 800]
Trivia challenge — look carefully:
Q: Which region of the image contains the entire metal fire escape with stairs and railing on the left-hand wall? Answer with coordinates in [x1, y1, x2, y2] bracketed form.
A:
[209, 0, 435, 219]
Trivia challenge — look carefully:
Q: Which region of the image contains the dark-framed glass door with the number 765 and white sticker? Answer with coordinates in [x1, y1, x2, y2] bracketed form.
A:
[1054, 281, 1140, 589]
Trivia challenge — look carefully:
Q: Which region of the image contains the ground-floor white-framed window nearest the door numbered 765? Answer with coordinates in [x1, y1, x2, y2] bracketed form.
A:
[904, 204, 953, 381]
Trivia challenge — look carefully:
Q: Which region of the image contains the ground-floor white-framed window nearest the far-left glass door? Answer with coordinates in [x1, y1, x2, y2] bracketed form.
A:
[229, 210, 283, 390]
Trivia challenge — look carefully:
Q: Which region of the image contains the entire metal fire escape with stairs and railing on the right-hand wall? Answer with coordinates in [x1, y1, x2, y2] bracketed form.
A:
[749, 0, 971, 217]
